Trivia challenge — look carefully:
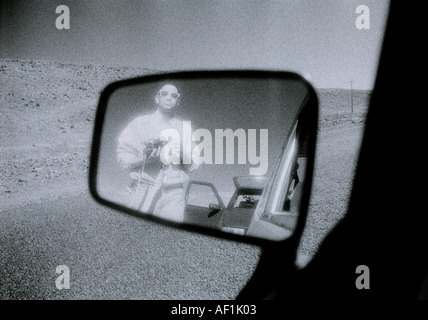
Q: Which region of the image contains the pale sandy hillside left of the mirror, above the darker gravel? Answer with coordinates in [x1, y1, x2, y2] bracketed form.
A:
[0, 59, 153, 210]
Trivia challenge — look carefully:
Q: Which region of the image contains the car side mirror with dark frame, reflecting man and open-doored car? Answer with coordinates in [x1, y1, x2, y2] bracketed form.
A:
[89, 71, 318, 242]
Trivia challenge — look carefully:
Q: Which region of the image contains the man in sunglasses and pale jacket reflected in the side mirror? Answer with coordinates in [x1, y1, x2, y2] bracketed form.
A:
[117, 84, 199, 223]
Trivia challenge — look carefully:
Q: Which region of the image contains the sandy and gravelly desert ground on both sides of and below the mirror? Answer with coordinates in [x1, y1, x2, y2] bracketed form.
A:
[0, 59, 370, 299]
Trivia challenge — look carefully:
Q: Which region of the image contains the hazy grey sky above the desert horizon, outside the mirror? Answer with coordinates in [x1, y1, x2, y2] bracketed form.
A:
[0, 0, 389, 89]
